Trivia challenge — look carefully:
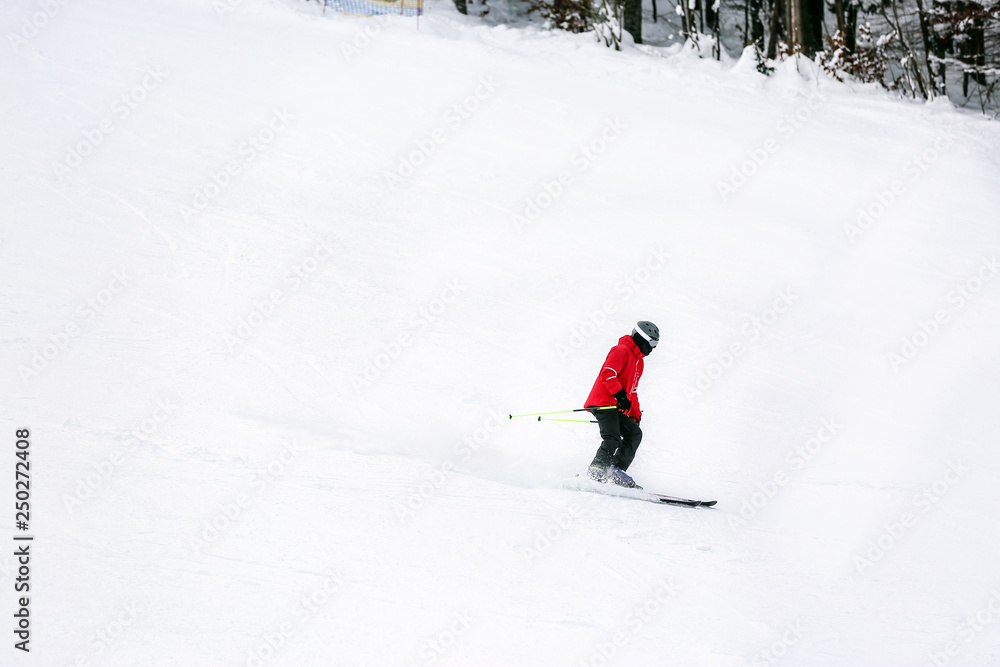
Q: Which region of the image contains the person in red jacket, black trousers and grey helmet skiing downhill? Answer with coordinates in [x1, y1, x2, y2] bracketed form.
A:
[583, 320, 660, 489]
